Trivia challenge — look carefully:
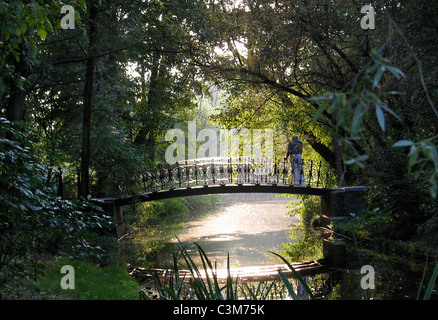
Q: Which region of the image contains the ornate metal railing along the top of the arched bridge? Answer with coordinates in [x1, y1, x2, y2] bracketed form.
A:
[142, 157, 335, 192]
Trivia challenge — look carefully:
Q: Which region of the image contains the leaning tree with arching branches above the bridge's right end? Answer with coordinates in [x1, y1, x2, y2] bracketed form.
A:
[188, 1, 376, 184]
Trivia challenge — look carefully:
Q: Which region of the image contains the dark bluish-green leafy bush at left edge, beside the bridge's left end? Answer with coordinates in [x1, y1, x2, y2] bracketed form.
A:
[0, 118, 111, 278]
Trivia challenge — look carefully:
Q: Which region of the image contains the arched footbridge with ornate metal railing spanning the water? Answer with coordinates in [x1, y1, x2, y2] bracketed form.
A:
[98, 157, 335, 207]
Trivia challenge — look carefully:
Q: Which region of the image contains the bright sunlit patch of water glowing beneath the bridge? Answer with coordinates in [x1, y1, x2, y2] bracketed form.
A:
[166, 194, 298, 267]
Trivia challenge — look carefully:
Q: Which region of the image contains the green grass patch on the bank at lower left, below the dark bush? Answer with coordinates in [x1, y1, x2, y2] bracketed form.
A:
[37, 260, 140, 300]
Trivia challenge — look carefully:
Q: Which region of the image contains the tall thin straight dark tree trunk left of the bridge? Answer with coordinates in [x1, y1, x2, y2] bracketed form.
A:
[78, 0, 97, 198]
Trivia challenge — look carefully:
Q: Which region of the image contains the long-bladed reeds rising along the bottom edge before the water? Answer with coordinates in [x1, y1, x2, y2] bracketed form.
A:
[140, 240, 438, 300]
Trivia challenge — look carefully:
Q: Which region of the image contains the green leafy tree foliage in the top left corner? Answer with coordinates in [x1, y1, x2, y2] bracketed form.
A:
[0, 1, 70, 131]
